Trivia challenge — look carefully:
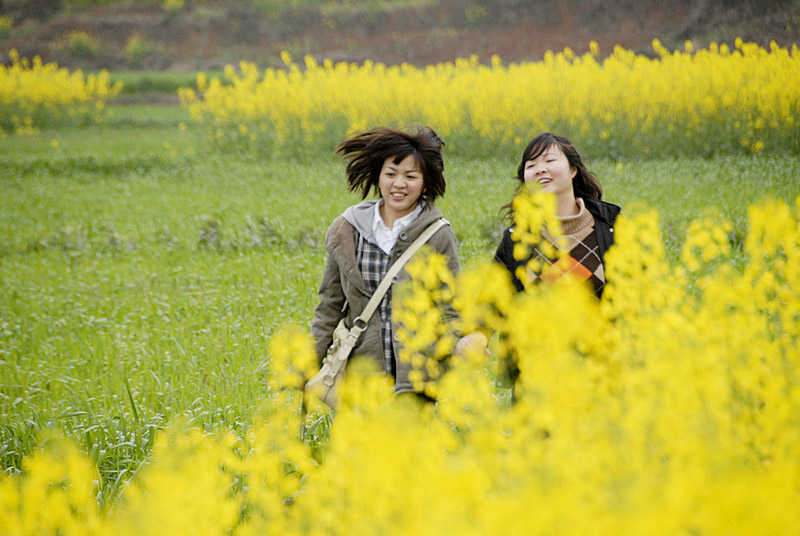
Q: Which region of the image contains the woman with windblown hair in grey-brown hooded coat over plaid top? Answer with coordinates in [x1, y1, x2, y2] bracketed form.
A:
[311, 127, 459, 402]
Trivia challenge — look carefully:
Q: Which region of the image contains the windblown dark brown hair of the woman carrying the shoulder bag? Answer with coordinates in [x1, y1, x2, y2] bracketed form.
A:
[336, 125, 445, 201]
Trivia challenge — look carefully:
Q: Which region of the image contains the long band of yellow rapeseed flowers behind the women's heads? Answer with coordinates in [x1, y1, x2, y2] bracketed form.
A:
[179, 39, 800, 156]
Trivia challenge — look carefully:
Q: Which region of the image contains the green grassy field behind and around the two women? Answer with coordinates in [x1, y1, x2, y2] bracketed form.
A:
[0, 105, 800, 502]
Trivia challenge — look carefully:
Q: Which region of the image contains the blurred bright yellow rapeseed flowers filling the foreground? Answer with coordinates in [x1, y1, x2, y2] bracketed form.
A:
[0, 199, 800, 535]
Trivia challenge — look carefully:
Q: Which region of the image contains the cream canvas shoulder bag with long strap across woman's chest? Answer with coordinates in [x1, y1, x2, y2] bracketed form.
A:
[304, 218, 447, 411]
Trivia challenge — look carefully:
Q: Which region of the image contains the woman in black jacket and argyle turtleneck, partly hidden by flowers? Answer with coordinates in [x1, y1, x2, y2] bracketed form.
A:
[494, 132, 620, 396]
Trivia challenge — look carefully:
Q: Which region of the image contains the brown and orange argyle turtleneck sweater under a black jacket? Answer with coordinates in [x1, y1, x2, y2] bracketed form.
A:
[495, 198, 605, 298]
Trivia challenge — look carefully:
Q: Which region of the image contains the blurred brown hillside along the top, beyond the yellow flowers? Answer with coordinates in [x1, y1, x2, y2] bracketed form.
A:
[0, 0, 800, 71]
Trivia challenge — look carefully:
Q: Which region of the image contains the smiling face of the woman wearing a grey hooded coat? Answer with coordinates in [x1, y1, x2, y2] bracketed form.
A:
[378, 155, 425, 223]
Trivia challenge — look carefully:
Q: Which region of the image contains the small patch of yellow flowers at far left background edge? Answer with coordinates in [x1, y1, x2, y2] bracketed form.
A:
[0, 50, 122, 135]
